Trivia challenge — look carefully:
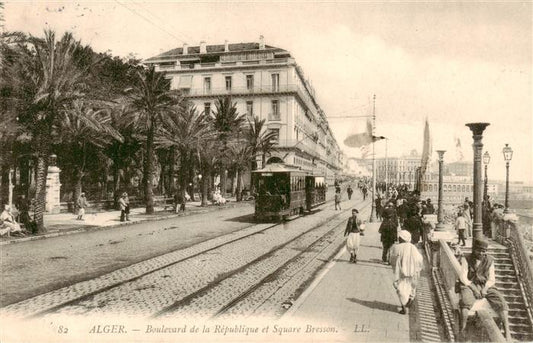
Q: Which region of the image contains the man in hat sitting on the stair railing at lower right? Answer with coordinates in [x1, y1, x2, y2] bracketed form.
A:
[459, 238, 511, 341]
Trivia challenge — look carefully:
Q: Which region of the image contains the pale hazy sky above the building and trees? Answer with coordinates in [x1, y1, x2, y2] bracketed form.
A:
[4, 0, 533, 183]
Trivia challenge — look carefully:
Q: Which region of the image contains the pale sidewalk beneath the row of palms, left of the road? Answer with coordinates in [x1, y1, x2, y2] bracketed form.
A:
[0, 198, 249, 246]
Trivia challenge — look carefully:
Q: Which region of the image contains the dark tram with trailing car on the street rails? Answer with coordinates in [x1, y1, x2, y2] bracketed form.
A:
[252, 163, 326, 220]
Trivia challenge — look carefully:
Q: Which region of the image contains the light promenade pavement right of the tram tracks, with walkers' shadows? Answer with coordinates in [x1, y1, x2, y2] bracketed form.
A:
[284, 223, 426, 342]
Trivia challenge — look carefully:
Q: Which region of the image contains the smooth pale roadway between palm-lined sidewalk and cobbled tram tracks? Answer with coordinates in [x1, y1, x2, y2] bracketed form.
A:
[0, 204, 254, 306]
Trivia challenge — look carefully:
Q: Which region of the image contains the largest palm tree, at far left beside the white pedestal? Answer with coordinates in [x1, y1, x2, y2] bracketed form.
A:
[1, 30, 92, 232]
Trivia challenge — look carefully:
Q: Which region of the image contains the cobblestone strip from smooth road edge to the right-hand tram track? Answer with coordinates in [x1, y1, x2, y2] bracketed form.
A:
[3, 194, 362, 316]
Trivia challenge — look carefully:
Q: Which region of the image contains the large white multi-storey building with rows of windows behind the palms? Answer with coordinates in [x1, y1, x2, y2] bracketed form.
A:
[144, 37, 342, 181]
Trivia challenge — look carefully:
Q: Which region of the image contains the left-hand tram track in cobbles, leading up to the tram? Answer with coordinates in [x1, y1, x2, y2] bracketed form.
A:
[1, 195, 366, 317]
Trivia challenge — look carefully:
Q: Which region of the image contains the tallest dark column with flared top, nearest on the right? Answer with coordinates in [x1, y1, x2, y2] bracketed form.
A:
[466, 123, 490, 248]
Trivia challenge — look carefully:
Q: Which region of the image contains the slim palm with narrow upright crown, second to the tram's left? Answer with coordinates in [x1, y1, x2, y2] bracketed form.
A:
[212, 96, 245, 195]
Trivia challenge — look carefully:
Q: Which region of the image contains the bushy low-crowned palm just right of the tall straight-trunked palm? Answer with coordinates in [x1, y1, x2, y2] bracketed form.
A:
[157, 106, 216, 211]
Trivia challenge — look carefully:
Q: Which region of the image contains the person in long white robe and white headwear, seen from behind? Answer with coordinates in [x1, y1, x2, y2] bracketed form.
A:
[390, 230, 424, 314]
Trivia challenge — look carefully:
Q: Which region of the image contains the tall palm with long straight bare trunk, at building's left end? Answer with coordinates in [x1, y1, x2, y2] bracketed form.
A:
[126, 67, 181, 214]
